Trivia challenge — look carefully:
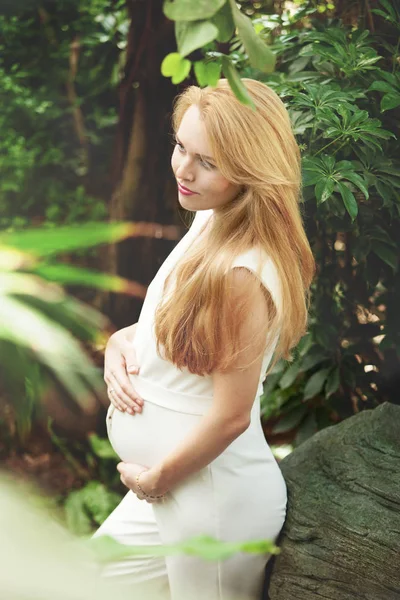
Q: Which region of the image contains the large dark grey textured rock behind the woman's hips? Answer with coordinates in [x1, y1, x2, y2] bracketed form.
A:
[265, 403, 400, 600]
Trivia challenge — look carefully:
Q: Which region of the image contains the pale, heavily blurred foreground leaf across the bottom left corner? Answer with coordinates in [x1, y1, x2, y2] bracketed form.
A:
[0, 475, 279, 600]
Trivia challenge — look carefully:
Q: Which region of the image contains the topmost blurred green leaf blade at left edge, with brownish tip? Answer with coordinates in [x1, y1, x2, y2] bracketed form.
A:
[0, 222, 136, 256]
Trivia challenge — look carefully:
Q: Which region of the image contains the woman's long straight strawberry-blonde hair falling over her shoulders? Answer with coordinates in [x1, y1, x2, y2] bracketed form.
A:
[155, 79, 315, 375]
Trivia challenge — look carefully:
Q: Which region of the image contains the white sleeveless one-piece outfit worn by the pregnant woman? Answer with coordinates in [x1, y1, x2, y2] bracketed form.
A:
[95, 209, 287, 600]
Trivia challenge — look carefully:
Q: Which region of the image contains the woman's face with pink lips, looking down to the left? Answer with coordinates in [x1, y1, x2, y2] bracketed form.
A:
[171, 104, 241, 211]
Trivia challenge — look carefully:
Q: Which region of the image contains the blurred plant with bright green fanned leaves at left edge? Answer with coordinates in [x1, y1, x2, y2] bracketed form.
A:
[0, 223, 139, 437]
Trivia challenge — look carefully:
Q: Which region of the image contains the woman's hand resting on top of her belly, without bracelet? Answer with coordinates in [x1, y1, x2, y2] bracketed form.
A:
[104, 330, 143, 415]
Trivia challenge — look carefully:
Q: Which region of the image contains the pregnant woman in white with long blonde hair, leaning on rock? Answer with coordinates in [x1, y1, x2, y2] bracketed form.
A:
[95, 79, 315, 600]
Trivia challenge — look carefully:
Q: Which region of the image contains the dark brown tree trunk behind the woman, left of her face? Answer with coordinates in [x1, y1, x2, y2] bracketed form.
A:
[102, 0, 184, 328]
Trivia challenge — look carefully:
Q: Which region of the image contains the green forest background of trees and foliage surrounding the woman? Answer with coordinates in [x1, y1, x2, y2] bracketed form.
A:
[0, 0, 400, 534]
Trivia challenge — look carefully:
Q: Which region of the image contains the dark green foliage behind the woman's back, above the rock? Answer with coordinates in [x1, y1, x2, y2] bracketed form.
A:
[247, 1, 400, 445]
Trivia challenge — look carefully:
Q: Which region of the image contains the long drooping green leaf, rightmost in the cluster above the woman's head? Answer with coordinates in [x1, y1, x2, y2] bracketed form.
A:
[229, 0, 276, 73]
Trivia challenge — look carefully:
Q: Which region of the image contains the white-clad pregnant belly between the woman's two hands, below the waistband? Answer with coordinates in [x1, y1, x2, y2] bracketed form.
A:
[107, 400, 201, 467]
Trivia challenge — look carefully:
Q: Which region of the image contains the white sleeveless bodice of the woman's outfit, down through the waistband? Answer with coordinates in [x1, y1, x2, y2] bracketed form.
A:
[130, 209, 281, 414]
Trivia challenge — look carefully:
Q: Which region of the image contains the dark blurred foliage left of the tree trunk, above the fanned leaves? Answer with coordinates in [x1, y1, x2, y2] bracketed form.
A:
[0, 0, 129, 228]
